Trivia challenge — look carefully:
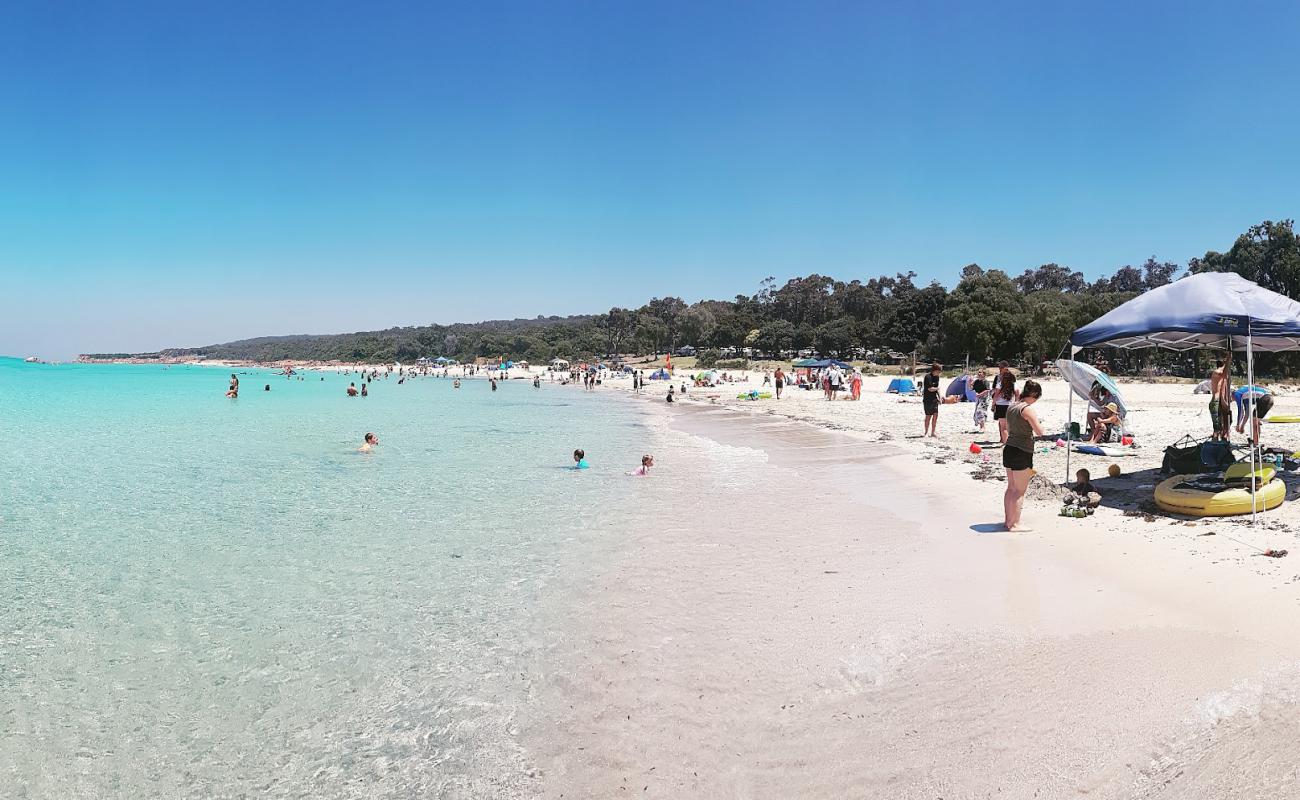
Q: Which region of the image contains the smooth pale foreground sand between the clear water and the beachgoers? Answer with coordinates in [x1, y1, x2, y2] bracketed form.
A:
[520, 381, 1300, 797]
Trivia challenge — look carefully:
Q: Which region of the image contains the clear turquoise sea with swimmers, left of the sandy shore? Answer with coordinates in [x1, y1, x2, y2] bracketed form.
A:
[0, 359, 671, 797]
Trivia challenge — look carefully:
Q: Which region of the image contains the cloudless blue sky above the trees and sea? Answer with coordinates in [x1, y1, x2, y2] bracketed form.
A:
[0, 0, 1300, 358]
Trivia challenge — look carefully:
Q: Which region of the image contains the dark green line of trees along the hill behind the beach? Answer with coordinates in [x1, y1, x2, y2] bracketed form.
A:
[98, 220, 1300, 366]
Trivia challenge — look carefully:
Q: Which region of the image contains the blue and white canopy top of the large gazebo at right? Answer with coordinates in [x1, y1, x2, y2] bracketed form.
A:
[1070, 272, 1300, 353]
